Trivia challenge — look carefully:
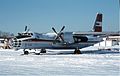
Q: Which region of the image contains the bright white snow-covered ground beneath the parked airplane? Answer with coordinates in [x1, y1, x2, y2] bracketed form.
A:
[0, 50, 120, 76]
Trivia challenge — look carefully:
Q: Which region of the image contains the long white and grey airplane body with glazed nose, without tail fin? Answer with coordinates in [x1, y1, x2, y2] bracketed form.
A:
[13, 32, 100, 49]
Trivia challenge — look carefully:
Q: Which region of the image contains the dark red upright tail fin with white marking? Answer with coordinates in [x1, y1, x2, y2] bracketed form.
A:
[93, 13, 103, 32]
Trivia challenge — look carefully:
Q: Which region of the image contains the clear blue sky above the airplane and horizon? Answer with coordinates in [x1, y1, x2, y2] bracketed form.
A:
[0, 0, 120, 33]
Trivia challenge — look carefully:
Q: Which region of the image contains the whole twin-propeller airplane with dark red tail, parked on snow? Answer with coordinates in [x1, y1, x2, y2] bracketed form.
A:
[13, 13, 103, 54]
